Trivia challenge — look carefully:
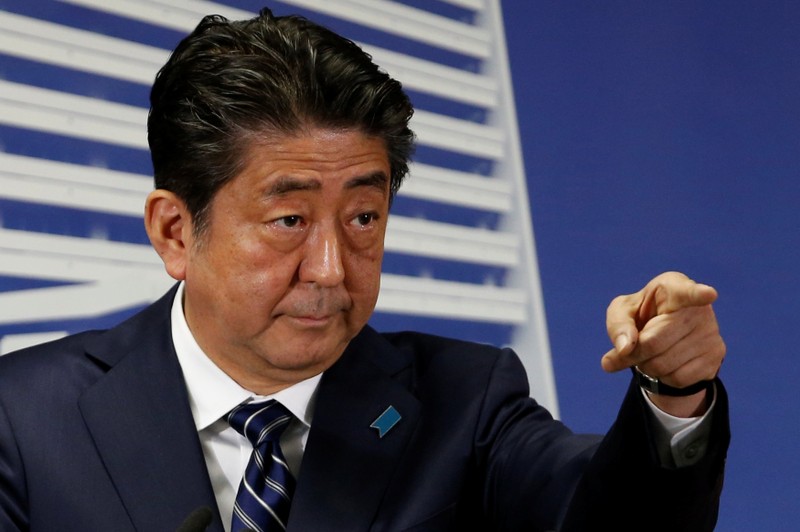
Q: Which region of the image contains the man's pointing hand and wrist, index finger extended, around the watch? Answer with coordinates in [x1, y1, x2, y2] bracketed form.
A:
[601, 272, 725, 417]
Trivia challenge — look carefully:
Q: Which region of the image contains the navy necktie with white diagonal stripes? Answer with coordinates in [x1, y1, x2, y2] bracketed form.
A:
[227, 400, 294, 532]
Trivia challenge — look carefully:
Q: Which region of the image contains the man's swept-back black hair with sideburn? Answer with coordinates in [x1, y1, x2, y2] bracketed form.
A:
[147, 8, 414, 234]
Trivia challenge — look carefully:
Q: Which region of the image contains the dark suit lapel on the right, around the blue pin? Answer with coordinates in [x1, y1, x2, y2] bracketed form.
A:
[289, 328, 420, 531]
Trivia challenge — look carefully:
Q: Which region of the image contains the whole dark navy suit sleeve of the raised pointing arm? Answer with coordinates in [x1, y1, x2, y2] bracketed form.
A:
[481, 352, 729, 532]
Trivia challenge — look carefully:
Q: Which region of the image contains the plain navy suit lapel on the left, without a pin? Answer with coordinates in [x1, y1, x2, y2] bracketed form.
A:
[80, 291, 222, 532]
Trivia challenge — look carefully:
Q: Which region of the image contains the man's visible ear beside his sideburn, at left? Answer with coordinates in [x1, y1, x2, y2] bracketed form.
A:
[144, 189, 193, 281]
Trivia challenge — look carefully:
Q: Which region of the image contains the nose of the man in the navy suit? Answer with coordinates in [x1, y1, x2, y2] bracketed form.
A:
[300, 221, 344, 287]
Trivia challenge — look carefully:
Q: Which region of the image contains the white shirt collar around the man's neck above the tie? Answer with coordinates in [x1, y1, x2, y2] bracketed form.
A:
[171, 283, 322, 432]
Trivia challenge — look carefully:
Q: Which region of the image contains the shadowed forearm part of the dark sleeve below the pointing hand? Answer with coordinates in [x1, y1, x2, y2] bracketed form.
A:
[561, 381, 730, 532]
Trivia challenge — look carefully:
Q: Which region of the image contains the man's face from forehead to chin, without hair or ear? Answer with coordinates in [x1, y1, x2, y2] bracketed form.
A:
[179, 129, 390, 393]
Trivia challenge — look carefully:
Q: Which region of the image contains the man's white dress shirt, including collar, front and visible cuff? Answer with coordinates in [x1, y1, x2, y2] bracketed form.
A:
[172, 283, 716, 531]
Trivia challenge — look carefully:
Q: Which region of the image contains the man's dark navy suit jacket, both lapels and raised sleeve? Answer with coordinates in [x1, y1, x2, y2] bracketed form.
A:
[0, 291, 729, 532]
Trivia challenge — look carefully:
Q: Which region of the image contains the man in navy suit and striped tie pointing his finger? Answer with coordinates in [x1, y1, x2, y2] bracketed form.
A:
[0, 10, 729, 531]
